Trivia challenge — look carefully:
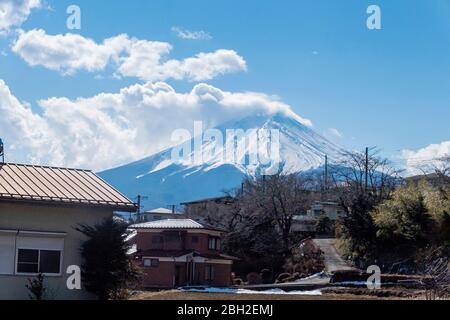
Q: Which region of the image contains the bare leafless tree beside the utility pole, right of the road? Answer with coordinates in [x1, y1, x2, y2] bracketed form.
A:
[331, 148, 401, 266]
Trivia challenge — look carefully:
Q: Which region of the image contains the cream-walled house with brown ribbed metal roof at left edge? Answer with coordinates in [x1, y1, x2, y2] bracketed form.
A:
[0, 163, 137, 300]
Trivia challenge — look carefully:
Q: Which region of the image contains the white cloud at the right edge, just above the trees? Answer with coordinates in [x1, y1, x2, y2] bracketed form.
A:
[402, 141, 450, 174]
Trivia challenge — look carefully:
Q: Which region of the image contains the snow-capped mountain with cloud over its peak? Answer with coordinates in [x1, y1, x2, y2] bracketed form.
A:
[100, 113, 341, 209]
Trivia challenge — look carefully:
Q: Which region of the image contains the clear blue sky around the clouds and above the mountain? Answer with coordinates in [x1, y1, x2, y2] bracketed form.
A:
[0, 0, 450, 172]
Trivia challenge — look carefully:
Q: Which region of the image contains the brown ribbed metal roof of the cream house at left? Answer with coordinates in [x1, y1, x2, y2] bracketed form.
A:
[0, 163, 137, 212]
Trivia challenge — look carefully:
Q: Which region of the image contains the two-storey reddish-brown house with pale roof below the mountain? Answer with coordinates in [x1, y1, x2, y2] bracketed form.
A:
[130, 219, 235, 289]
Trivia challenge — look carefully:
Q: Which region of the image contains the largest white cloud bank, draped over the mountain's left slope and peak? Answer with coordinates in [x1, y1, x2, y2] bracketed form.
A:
[0, 80, 311, 170]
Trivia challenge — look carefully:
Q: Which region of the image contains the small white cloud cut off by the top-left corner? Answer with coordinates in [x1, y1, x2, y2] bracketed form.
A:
[0, 0, 41, 33]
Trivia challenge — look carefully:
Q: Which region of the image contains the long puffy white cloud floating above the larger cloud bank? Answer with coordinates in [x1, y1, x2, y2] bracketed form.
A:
[12, 29, 247, 81]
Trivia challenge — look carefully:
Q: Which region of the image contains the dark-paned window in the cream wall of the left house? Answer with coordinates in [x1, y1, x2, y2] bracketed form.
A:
[17, 249, 61, 274]
